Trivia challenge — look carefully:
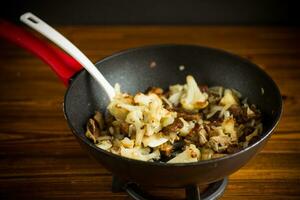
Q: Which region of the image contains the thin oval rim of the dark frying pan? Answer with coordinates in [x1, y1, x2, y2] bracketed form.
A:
[63, 44, 283, 167]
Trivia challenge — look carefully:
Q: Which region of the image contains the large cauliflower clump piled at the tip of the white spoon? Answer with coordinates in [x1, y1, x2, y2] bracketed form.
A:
[108, 89, 177, 146]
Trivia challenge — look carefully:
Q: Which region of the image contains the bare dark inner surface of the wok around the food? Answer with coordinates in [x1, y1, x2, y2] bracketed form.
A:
[65, 45, 281, 152]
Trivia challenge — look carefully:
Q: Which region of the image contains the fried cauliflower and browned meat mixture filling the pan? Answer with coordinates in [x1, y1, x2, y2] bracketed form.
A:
[86, 76, 263, 163]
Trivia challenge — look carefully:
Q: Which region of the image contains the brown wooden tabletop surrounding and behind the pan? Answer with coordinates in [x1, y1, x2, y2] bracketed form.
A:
[0, 26, 300, 200]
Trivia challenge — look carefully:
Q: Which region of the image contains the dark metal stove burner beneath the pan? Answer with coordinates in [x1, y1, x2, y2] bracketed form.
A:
[112, 176, 228, 200]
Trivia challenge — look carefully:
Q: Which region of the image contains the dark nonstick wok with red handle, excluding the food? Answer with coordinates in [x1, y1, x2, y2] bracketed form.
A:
[0, 21, 282, 199]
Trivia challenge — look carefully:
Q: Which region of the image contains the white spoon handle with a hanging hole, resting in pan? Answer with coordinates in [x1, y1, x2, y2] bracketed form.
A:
[20, 12, 115, 99]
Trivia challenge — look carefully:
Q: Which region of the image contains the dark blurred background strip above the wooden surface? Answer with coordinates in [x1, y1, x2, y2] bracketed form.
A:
[0, 0, 300, 26]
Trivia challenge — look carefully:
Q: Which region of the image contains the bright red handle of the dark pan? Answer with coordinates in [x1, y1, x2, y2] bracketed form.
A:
[0, 19, 82, 86]
